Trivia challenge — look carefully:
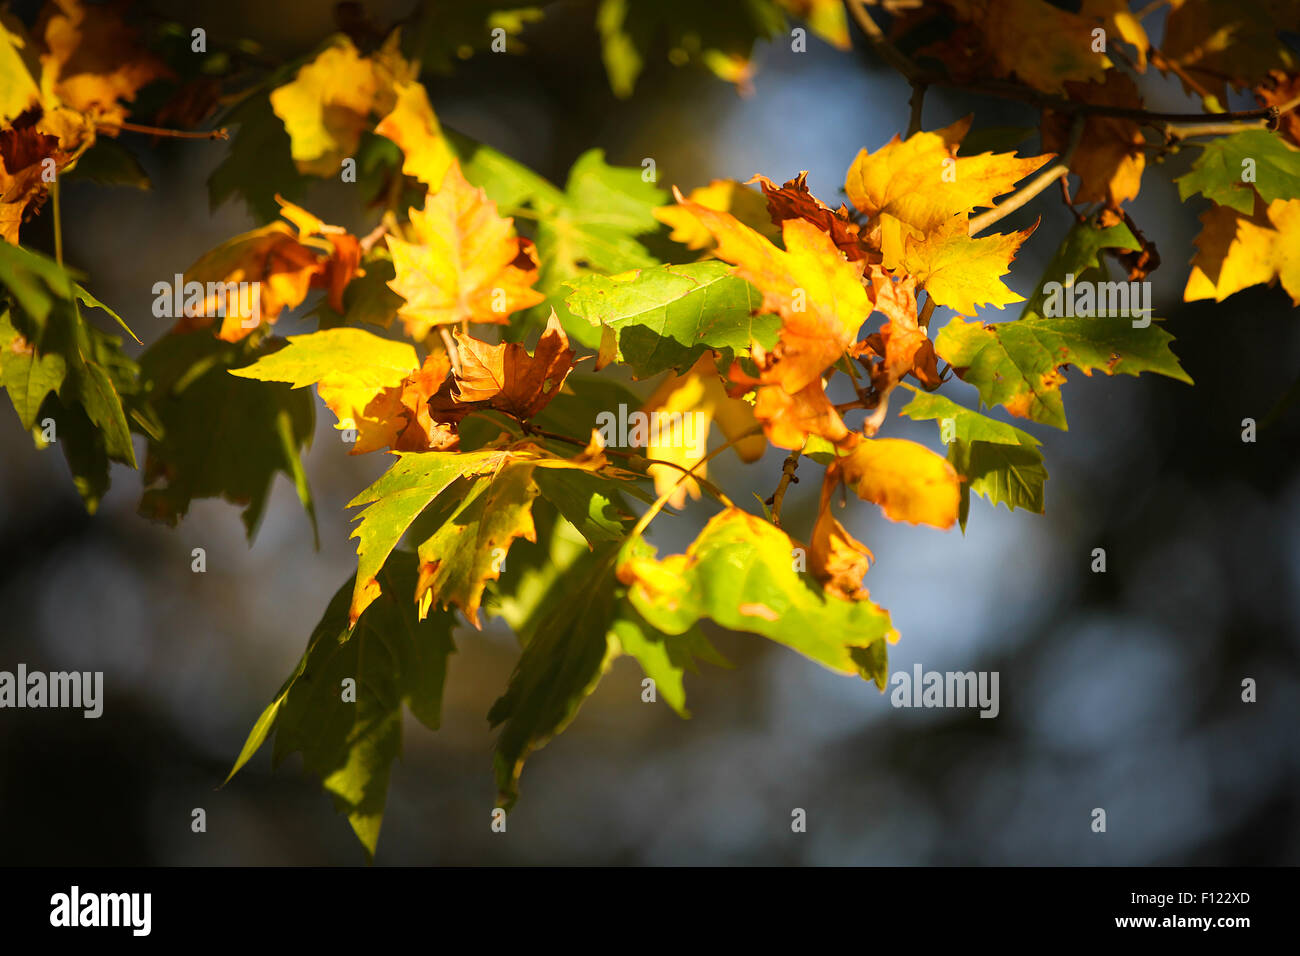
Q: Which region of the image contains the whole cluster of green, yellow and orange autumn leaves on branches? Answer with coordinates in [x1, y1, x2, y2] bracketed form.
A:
[0, 0, 1300, 852]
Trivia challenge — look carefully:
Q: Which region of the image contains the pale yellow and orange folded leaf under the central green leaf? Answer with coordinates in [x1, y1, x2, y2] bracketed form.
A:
[641, 355, 767, 509]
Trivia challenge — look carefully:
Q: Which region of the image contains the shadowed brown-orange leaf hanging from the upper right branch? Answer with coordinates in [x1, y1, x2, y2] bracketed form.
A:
[1043, 70, 1147, 207]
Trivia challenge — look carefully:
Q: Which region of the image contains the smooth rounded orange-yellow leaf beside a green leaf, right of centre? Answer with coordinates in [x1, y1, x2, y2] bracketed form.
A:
[828, 438, 961, 528]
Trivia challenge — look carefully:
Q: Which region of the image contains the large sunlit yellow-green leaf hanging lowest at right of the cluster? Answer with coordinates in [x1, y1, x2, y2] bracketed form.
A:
[620, 509, 894, 689]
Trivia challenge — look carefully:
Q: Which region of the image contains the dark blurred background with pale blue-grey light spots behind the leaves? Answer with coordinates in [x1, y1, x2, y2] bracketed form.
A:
[0, 0, 1300, 865]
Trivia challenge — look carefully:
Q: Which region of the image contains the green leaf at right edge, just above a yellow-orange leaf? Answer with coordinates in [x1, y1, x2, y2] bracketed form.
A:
[1175, 130, 1300, 216]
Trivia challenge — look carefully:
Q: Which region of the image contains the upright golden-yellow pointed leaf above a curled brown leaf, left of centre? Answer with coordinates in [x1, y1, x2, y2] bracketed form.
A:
[386, 161, 545, 339]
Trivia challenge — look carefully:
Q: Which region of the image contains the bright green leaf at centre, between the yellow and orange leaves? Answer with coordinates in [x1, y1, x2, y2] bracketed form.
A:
[567, 261, 780, 378]
